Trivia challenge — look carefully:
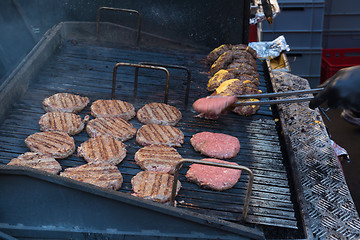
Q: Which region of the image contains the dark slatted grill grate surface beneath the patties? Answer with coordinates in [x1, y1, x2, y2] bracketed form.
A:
[0, 41, 298, 229]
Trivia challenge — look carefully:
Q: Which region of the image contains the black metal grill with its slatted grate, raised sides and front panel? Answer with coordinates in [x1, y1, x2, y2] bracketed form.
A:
[0, 7, 358, 239]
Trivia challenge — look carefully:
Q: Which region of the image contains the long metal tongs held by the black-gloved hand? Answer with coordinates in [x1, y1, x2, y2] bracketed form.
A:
[235, 88, 324, 106]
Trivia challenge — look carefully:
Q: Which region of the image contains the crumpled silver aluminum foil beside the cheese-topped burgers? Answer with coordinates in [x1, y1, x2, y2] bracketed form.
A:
[249, 35, 290, 59]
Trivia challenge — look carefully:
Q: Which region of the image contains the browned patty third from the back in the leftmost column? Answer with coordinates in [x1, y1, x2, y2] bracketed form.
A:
[25, 131, 75, 158]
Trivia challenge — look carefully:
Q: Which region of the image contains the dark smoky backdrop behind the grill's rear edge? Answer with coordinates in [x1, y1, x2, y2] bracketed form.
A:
[0, 0, 250, 83]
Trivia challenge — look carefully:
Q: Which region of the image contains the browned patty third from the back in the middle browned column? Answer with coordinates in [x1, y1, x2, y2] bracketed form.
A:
[78, 136, 126, 165]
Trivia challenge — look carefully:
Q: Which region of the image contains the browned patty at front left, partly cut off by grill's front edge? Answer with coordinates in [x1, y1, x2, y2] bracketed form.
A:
[7, 152, 61, 174]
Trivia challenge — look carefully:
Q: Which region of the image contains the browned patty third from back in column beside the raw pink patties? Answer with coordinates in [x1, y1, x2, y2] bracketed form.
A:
[135, 145, 182, 174]
